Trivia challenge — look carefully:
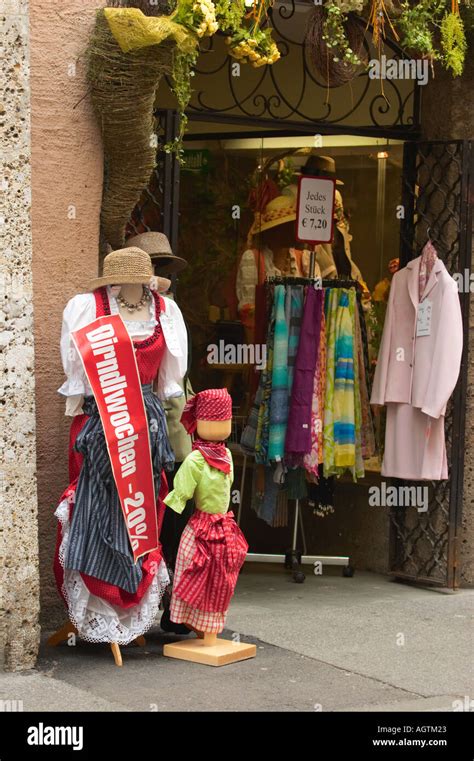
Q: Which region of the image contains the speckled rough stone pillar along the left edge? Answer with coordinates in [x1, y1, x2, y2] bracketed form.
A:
[0, 0, 39, 670]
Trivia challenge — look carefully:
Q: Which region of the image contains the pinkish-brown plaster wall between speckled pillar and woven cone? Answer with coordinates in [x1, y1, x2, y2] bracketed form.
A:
[30, 0, 103, 626]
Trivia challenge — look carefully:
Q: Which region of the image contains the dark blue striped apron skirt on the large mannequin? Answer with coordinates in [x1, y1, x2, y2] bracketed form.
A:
[64, 384, 174, 594]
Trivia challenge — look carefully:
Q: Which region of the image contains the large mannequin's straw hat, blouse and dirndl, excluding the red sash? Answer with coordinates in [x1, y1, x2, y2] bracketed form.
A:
[50, 248, 187, 665]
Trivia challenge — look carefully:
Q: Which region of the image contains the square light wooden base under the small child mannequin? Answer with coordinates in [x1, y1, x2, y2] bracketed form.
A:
[163, 632, 257, 666]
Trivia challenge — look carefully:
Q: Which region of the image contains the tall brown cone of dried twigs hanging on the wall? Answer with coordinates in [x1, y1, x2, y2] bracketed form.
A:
[87, 11, 173, 248]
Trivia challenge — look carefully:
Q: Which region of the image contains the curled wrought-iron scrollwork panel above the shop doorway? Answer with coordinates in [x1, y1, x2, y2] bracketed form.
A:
[162, 0, 420, 139]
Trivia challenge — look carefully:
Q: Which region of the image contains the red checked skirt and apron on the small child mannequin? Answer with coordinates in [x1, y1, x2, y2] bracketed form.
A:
[170, 510, 248, 633]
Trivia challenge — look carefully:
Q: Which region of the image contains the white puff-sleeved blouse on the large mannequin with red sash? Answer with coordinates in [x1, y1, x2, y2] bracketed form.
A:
[58, 286, 188, 415]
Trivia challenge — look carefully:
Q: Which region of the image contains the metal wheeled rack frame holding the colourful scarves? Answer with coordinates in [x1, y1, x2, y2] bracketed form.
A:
[237, 274, 356, 584]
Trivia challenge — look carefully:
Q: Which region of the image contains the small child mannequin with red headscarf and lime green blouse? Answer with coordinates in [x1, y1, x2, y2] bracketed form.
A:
[163, 389, 256, 666]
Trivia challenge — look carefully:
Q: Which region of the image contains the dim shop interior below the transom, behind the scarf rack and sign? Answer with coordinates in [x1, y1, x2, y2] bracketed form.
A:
[170, 130, 403, 568]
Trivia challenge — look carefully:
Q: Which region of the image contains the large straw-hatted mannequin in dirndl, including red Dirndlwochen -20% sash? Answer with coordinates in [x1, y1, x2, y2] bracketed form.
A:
[50, 247, 187, 665]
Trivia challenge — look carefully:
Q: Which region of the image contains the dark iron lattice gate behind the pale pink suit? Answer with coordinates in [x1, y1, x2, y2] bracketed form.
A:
[390, 141, 473, 588]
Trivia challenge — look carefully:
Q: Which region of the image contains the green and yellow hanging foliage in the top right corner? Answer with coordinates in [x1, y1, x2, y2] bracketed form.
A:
[307, 0, 472, 84]
